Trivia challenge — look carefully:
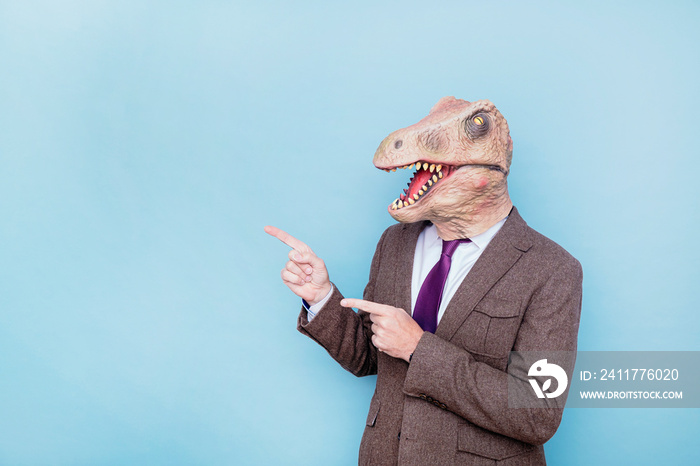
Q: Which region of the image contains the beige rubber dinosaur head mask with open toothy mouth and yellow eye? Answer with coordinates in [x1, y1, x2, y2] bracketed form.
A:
[374, 97, 513, 239]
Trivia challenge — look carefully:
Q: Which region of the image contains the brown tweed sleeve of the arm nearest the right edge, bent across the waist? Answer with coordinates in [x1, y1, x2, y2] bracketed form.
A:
[404, 258, 582, 445]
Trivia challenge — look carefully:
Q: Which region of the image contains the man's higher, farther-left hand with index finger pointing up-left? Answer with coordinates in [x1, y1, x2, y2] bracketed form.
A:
[265, 226, 331, 305]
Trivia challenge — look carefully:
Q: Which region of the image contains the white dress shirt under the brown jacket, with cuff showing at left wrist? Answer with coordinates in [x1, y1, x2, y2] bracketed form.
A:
[304, 217, 508, 322]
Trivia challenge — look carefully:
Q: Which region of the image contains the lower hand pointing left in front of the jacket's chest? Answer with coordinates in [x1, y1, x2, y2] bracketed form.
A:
[340, 299, 423, 362]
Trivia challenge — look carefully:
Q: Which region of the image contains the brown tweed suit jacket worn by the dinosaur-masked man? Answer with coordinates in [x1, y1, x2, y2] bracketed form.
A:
[298, 208, 582, 466]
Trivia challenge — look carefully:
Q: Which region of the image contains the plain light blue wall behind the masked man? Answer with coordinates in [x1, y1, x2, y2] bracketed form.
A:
[0, 0, 700, 465]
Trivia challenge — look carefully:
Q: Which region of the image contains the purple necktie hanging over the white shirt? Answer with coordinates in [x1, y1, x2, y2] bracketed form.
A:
[413, 238, 471, 333]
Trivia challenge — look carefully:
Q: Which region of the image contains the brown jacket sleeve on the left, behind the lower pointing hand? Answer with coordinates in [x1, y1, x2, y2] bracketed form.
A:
[297, 231, 387, 377]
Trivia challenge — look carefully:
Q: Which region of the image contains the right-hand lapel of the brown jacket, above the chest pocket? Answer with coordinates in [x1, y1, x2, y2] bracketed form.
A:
[434, 207, 529, 340]
